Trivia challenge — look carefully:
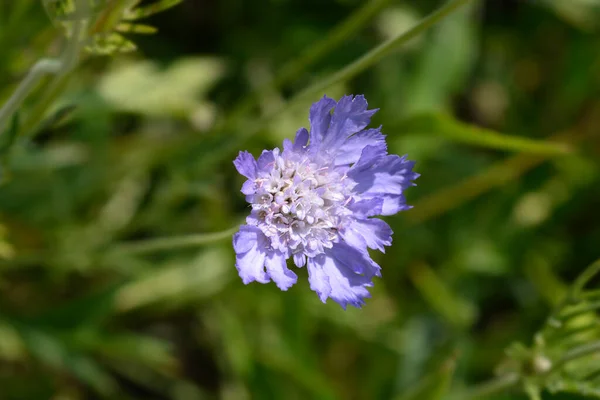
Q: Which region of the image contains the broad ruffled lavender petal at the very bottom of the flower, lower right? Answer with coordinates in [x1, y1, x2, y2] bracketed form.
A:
[307, 246, 373, 310]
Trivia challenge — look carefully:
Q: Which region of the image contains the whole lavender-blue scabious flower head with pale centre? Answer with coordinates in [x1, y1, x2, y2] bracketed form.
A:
[233, 96, 419, 309]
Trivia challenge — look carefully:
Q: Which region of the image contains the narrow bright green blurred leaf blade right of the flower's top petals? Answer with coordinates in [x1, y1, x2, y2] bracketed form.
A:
[398, 113, 572, 155]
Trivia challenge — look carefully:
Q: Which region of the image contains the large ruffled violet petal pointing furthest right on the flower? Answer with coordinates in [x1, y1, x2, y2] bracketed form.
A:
[348, 146, 419, 215]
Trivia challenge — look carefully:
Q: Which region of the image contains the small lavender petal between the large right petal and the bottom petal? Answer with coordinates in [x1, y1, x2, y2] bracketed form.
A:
[340, 218, 393, 253]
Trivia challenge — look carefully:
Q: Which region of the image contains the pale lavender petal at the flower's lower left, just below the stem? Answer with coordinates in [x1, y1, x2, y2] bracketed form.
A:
[233, 225, 270, 285]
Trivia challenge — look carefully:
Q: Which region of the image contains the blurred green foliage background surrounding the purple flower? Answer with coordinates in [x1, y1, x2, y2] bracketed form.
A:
[0, 0, 600, 400]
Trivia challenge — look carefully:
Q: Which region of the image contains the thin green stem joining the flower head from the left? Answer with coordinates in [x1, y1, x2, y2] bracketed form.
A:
[111, 225, 239, 255]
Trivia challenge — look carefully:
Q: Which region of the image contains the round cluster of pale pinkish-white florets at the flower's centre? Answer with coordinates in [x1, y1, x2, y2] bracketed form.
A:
[252, 155, 350, 257]
